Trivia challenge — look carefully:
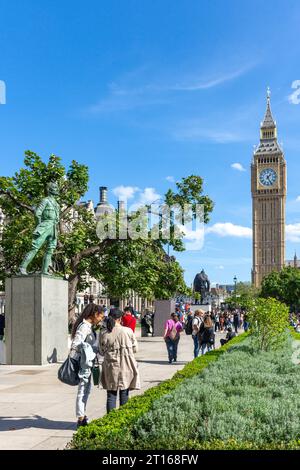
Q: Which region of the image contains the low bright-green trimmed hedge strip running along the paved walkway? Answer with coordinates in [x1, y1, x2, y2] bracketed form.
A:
[68, 333, 248, 450]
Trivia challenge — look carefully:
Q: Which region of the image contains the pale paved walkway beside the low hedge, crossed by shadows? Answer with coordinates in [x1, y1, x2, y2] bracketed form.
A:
[0, 333, 225, 450]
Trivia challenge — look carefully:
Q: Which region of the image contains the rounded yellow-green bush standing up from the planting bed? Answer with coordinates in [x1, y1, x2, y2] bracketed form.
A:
[248, 298, 289, 351]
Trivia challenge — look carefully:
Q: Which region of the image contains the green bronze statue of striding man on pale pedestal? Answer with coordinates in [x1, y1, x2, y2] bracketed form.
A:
[19, 182, 59, 275]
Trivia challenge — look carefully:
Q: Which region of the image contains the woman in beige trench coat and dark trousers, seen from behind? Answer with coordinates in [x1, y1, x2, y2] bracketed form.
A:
[99, 309, 141, 413]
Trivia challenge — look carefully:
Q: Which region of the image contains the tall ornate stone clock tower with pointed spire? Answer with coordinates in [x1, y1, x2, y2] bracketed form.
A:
[251, 89, 286, 287]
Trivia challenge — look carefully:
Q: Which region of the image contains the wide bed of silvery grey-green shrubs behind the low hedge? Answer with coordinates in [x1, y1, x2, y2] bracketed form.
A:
[131, 338, 300, 450]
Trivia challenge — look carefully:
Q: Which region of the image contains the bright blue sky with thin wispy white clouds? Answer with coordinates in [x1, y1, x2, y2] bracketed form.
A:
[0, 0, 300, 283]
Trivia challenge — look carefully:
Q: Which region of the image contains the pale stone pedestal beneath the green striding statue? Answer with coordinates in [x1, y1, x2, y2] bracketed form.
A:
[5, 274, 68, 365]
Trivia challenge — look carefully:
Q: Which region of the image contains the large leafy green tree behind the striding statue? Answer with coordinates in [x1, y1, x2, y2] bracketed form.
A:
[0, 151, 213, 318]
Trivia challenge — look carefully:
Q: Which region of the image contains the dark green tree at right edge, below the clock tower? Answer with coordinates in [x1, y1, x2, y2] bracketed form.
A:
[261, 266, 300, 310]
